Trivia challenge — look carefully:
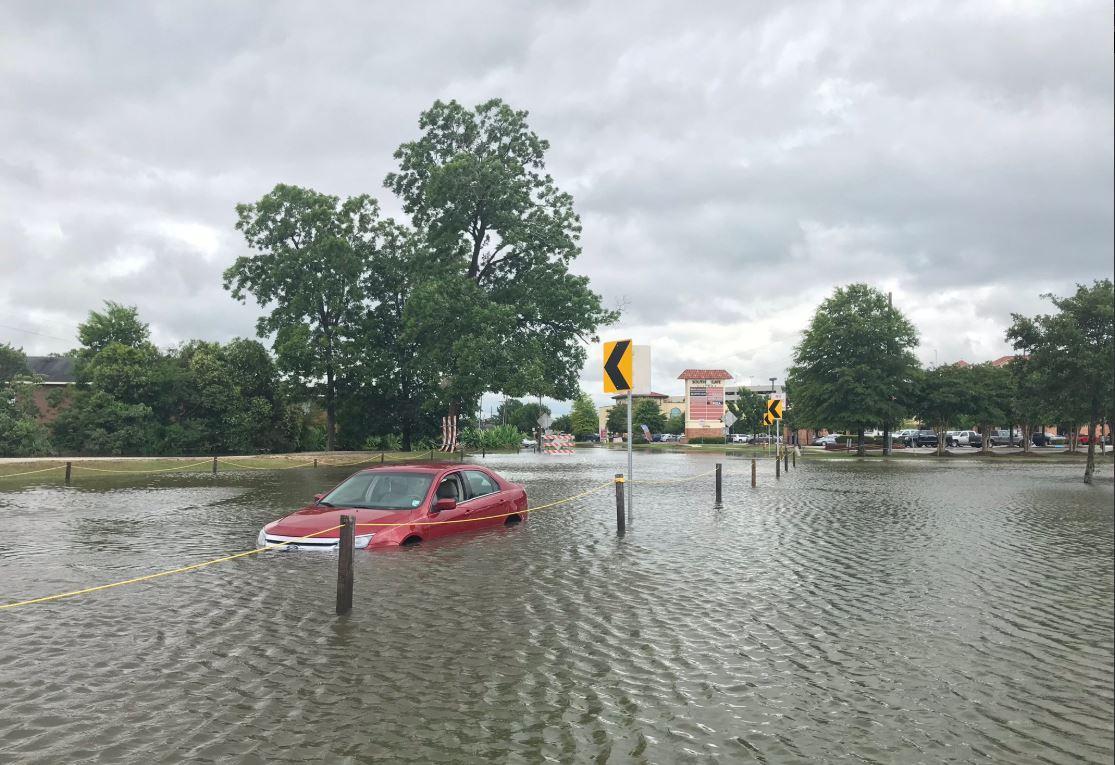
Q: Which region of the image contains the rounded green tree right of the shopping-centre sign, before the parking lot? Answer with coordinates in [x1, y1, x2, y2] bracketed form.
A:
[787, 284, 918, 455]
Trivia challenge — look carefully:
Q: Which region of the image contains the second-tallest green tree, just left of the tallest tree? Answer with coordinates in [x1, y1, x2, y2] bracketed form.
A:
[224, 184, 380, 451]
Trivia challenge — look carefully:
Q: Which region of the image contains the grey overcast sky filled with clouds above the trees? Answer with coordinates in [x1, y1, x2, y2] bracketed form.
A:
[0, 0, 1115, 412]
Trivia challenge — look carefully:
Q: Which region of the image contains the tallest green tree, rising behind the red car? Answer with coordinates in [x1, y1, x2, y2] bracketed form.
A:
[385, 99, 617, 411]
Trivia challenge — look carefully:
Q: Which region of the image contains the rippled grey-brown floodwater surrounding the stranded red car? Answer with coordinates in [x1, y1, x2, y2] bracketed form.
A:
[0, 449, 1115, 763]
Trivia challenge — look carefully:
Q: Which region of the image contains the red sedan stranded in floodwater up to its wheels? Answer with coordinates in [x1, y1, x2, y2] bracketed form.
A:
[258, 463, 526, 550]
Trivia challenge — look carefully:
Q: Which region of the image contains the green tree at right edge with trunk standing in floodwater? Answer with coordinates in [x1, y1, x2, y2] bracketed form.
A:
[1007, 279, 1115, 483]
